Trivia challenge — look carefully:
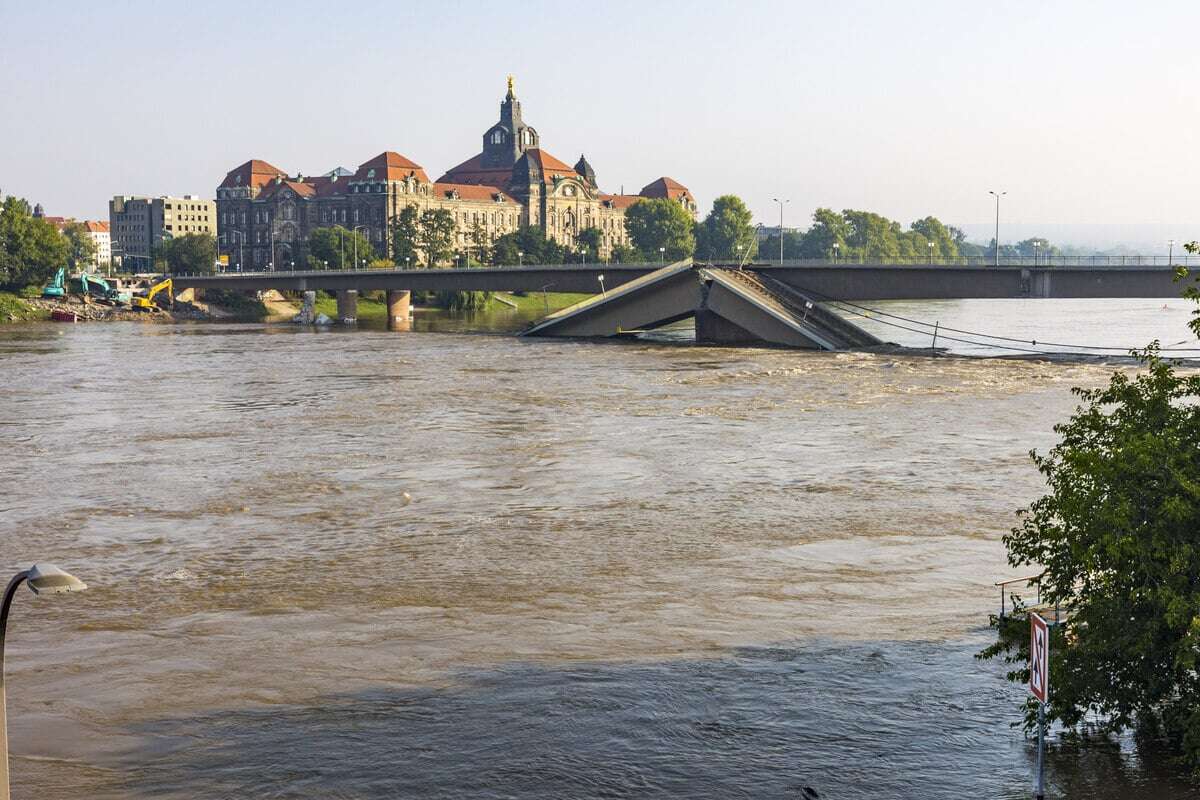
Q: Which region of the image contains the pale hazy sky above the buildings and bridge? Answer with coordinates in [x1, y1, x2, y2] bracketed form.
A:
[0, 0, 1200, 240]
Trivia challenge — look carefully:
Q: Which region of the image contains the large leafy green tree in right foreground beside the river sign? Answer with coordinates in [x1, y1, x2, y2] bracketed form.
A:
[980, 245, 1200, 769]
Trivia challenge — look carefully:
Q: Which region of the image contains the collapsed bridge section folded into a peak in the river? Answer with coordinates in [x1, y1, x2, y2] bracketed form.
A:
[524, 260, 882, 350]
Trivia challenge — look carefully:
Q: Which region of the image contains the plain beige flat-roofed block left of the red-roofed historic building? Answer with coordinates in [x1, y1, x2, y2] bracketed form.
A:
[108, 194, 217, 272]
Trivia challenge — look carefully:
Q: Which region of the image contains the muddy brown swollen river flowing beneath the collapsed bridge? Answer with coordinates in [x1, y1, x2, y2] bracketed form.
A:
[0, 301, 1194, 799]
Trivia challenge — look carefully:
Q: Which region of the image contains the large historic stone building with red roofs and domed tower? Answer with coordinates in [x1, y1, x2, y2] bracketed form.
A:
[216, 78, 696, 270]
